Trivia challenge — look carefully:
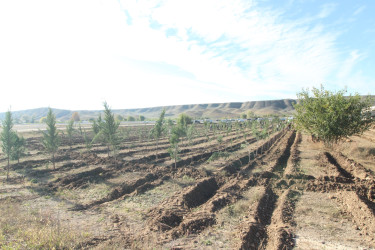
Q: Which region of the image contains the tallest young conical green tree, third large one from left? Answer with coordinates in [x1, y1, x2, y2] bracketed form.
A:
[94, 102, 120, 157]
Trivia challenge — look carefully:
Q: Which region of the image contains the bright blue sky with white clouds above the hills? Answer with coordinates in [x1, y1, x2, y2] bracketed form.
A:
[0, 0, 375, 111]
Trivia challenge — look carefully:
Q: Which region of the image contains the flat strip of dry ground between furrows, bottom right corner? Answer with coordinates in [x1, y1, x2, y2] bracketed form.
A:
[294, 192, 366, 249]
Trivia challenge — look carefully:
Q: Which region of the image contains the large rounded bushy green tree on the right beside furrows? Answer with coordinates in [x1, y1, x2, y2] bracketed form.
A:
[294, 86, 372, 146]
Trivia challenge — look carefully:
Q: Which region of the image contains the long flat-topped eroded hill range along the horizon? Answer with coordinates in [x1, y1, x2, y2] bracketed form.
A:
[0, 96, 375, 122]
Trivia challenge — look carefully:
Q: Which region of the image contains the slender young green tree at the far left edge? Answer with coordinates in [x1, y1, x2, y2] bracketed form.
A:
[0, 111, 17, 180]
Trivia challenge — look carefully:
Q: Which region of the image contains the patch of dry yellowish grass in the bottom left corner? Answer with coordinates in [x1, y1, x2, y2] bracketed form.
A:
[0, 199, 89, 249]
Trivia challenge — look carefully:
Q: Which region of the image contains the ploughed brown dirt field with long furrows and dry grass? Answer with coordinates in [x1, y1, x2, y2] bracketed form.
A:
[0, 126, 375, 249]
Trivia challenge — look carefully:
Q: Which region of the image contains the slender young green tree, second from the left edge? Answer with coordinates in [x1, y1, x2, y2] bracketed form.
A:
[42, 108, 60, 169]
